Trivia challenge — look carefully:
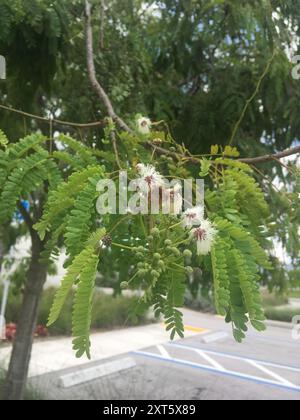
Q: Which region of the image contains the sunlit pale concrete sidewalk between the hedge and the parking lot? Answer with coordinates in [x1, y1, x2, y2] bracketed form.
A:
[0, 324, 201, 377]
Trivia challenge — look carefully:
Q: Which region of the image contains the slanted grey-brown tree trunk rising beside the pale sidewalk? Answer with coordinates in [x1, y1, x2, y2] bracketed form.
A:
[3, 237, 47, 401]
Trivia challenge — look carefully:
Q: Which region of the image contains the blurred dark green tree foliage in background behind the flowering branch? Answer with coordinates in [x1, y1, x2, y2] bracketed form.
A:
[0, 0, 299, 396]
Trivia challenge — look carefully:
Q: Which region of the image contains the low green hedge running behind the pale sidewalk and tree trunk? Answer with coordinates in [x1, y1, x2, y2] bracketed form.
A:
[0, 288, 150, 335]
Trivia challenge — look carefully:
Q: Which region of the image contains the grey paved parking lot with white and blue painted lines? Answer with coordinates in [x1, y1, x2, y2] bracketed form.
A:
[31, 314, 300, 400]
